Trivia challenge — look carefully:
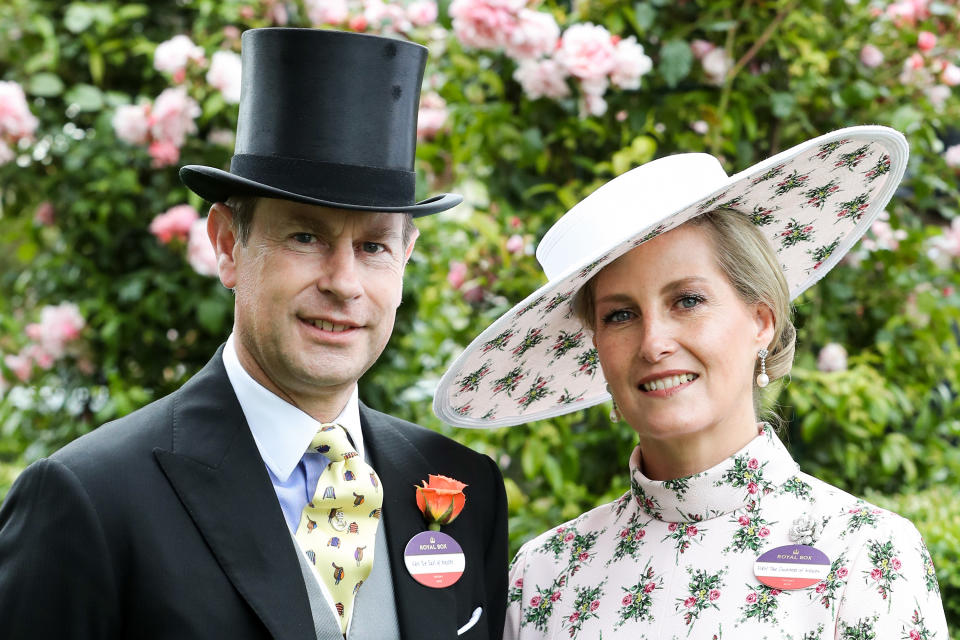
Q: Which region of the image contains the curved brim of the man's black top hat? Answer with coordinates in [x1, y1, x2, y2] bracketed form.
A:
[180, 164, 463, 218]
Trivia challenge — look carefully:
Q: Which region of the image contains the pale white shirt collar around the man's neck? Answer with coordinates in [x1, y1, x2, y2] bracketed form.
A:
[223, 333, 363, 482]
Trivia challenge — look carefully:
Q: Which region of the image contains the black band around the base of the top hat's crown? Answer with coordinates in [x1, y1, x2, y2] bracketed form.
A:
[230, 153, 416, 207]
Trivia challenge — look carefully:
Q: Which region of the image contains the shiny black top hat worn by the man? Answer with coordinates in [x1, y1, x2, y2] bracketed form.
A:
[180, 28, 463, 216]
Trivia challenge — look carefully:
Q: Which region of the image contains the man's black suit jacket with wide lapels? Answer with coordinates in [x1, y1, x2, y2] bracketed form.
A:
[0, 352, 507, 640]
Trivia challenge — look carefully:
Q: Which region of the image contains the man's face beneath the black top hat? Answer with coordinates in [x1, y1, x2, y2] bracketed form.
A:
[211, 198, 414, 406]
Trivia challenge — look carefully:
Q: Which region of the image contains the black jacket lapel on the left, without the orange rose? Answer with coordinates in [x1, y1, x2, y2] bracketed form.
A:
[154, 347, 315, 640]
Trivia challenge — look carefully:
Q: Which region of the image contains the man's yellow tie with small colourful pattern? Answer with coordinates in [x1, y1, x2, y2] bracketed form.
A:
[296, 424, 383, 635]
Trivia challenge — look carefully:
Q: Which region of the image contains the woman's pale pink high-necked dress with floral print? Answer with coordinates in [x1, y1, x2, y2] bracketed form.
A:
[504, 426, 949, 640]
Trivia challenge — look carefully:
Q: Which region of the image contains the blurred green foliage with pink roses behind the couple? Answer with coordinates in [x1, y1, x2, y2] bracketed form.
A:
[0, 0, 960, 638]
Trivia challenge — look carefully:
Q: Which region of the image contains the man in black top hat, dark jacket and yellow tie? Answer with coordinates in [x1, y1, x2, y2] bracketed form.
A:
[0, 29, 507, 640]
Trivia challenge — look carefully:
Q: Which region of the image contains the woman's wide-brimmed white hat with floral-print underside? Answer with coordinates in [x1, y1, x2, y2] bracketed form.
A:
[433, 126, 908, 428]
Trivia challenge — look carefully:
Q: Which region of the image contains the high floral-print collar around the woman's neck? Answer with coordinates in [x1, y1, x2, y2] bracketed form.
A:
[630, 423, 800, 522]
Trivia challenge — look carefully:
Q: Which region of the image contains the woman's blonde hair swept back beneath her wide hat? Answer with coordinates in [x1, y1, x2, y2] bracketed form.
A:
[571, 209, 797, 392]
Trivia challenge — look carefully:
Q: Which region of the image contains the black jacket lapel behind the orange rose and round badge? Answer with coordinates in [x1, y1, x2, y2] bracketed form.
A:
[360, 404, 457, 640]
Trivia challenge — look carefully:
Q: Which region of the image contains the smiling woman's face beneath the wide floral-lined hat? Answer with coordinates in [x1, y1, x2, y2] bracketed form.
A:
[593, 225, 774, 445]
